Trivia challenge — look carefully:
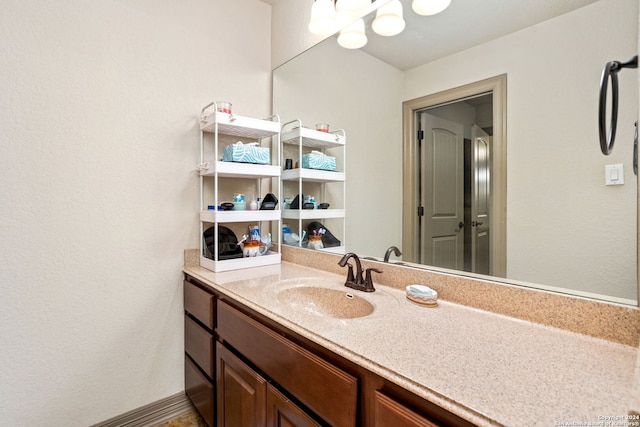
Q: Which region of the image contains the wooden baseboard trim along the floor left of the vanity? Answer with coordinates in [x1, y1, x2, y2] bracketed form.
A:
[91, 391, 195, 427]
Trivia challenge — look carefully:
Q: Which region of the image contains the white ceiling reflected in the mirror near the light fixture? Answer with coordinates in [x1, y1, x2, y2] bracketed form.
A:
[362, 0, 596, 70]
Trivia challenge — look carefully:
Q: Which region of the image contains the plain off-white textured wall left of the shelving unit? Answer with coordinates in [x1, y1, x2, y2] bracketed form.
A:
[0, 0, 271, 426]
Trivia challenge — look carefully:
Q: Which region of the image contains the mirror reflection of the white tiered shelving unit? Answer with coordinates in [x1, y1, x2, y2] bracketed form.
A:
[280, 120, 346, 254]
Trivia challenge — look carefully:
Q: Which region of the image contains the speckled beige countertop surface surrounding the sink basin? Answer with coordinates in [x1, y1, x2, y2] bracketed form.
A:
[184, 262, 638, 426]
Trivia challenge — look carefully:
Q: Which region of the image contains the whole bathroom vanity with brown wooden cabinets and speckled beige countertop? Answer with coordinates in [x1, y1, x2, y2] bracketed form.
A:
[184, 262, 637, 426]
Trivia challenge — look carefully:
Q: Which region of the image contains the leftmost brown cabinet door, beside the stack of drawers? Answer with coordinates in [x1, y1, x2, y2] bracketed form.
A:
[216, 343, 267, 427]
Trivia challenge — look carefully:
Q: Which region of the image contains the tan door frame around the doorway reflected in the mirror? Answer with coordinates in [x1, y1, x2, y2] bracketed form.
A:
[402, 74, 507, 277]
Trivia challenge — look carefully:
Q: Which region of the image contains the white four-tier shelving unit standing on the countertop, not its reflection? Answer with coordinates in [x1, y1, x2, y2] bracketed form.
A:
[197, 102, 282, 272]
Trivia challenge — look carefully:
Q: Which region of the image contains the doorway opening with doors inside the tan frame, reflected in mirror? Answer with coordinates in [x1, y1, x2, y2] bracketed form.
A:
[404, 93, 496, 276]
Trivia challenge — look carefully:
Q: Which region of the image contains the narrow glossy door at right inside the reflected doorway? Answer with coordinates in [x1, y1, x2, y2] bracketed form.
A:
[470, 125, 491, 274]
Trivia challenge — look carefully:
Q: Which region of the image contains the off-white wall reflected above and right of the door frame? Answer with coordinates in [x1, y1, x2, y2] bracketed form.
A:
[403, 0, 638, 300]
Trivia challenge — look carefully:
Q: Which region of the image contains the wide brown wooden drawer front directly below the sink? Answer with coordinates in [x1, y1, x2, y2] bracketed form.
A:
[217, 301, 358, 427]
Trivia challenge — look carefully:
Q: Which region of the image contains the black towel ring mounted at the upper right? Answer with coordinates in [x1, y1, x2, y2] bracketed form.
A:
[598, 55, 638, 155]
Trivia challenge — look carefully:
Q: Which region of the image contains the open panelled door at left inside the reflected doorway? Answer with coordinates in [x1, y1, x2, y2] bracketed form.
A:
[418, 112, 464, 270]
